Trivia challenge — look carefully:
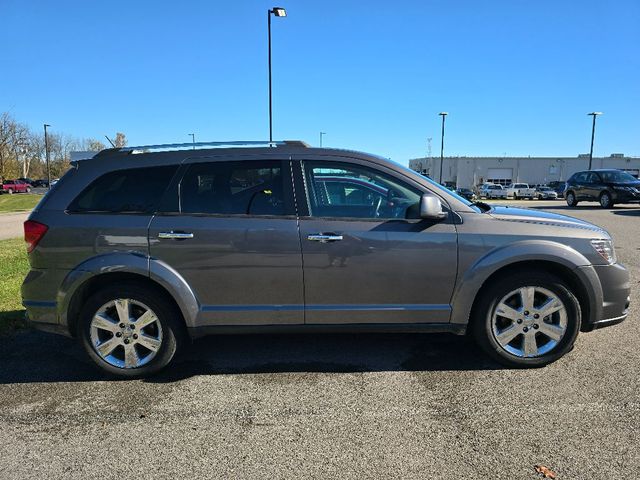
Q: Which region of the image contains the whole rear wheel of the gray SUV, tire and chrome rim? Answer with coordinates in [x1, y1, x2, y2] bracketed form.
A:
[78, 284, 184, 378]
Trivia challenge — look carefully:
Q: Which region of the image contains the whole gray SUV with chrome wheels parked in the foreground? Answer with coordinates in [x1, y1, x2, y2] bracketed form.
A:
[22, 142, 629, 377]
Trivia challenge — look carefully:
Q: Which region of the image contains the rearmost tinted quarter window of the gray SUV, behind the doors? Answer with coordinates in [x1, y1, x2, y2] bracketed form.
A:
[68, 165, 178, 213]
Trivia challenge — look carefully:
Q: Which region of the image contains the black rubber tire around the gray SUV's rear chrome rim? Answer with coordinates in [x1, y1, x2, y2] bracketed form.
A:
[77, 283, 186, 378]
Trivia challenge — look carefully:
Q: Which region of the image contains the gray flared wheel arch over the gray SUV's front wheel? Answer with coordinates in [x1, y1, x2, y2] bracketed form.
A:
[451, 240, 603, 324]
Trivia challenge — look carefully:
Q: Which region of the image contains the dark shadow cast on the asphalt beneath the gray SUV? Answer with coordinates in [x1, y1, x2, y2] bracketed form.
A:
[0, 331, 505, 385]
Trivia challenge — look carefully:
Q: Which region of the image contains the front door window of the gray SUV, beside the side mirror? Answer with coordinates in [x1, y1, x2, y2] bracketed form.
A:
[304, 162, 421, 219]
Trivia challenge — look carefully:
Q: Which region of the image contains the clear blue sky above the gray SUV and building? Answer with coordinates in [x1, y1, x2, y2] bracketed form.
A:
[0, 0, 640, 163]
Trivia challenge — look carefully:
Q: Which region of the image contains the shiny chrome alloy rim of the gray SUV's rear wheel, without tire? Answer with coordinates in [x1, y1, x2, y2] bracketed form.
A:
[89, 298, 162, 368]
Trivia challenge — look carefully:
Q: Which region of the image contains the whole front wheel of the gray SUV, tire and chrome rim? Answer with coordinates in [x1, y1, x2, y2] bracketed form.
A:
[472, 272, 581, 368]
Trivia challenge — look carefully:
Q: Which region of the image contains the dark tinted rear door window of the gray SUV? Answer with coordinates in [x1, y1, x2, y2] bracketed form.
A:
[180, 161, 290, 215]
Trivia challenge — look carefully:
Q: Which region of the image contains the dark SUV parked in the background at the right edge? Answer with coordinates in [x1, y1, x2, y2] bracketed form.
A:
[564, 170, 640, 208]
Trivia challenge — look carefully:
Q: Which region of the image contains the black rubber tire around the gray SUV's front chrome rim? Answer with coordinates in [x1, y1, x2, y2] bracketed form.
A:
[471, 272, 582, 368]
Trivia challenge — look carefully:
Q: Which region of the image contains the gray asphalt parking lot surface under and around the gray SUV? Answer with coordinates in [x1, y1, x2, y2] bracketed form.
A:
[0, 201, 640, 479]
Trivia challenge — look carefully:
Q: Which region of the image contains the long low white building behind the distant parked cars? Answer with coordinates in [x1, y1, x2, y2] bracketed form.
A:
[409, 153, 640, 188]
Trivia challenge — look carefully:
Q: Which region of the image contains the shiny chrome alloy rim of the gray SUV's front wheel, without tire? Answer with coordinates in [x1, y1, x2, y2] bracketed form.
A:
[491, 287, 567, 358]
